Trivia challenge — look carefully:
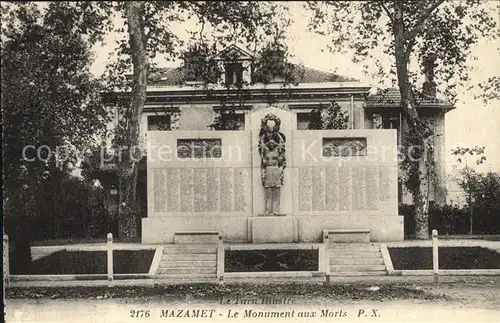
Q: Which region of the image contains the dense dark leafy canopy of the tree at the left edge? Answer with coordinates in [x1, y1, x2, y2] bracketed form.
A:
[1, 3, 107, 188]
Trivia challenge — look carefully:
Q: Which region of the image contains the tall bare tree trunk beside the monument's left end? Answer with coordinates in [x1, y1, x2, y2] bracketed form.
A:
[118, 1, 148, 241]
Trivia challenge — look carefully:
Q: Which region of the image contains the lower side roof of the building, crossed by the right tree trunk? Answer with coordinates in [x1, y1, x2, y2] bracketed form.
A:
[365, 88, 455, 110]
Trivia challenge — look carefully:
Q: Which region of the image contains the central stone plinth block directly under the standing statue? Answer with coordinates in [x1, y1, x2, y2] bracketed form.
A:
[251, 216, 298, 243]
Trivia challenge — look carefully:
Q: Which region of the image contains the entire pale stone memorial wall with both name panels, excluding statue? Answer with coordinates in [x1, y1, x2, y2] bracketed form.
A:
[142, 117, 403, 243]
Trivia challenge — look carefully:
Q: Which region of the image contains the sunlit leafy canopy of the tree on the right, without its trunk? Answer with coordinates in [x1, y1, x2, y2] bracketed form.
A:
[306, 0, 499, 103]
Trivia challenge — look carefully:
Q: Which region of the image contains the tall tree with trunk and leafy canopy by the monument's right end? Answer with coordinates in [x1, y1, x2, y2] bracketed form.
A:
[307, 0, 497, 239]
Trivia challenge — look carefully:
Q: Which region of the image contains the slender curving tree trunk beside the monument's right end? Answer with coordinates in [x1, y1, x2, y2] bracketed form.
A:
[393, 1, 429, 239]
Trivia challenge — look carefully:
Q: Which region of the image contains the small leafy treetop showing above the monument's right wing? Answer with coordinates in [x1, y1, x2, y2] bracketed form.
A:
[308, 101, 349, 130]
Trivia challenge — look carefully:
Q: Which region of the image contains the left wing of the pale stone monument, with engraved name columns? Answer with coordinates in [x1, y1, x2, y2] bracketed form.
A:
[142, 131, 252, 243]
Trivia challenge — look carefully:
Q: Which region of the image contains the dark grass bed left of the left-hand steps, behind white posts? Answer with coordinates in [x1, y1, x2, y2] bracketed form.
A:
[24, 250, 155, 275]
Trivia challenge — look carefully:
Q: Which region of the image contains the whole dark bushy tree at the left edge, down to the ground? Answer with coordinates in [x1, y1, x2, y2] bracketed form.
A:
[1, 3, 106, 261]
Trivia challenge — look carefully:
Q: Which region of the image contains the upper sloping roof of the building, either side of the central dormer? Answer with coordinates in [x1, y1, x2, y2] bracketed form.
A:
[149, 67, 358, 86]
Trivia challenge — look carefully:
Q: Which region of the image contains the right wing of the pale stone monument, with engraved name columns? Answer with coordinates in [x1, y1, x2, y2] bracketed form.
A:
[291, 129, 403, 242]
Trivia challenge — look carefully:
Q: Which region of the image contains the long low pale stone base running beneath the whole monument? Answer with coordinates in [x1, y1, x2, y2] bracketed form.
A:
[142, 213, 404, 244]
